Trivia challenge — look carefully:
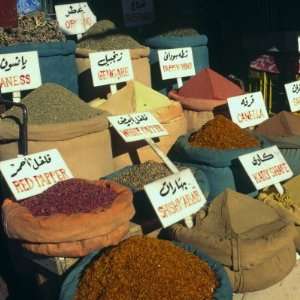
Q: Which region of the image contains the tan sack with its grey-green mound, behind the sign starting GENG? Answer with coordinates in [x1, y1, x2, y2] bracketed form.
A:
[76, 20, 151, 102]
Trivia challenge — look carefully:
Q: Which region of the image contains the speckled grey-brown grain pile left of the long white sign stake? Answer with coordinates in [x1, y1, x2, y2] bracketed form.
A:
[109, 161, 171, 191]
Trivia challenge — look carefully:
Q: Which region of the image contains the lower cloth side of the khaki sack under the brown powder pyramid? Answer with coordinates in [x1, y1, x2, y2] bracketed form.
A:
[225, 243, 296, 293]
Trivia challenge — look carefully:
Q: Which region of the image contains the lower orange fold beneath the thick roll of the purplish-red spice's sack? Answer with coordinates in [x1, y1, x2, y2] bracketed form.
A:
[22, 222, 129, 257]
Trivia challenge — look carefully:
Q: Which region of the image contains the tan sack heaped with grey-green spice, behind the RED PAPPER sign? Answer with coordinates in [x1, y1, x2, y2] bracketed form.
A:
[0, 83, 113, 180]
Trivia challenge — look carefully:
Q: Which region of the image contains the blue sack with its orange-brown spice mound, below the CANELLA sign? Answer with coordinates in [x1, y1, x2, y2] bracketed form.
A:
[168, 115, 270, 201]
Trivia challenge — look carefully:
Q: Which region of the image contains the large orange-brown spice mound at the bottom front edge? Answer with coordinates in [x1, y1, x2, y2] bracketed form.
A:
[75, 237, 218, 300]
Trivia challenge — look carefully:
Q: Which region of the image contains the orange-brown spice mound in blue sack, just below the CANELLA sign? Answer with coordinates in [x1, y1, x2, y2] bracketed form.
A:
[189, 115, 259, 149]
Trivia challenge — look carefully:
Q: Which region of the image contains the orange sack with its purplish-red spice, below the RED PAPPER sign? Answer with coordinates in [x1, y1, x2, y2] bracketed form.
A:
[2, 178, 134, 257]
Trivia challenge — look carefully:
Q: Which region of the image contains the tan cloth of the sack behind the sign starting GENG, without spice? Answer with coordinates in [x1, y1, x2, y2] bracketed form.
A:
[76, 47, 151, 102]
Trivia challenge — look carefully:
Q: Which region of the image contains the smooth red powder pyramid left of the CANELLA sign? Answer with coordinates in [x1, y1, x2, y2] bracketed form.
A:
[178, 68, 244, 100]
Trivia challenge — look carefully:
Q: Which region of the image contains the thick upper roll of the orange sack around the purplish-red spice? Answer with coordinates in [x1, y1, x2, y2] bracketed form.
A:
[2, 180, 135, 255]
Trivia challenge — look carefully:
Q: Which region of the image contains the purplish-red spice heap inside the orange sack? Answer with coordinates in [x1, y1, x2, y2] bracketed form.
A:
[21, 179, 117, 216]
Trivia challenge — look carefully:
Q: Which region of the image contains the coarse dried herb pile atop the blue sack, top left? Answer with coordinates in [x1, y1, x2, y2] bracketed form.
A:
[0, 12, 66, 46]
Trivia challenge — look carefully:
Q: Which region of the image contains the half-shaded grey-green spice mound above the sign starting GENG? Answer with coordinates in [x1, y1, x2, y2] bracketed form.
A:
[77, 20, 144, 51]
